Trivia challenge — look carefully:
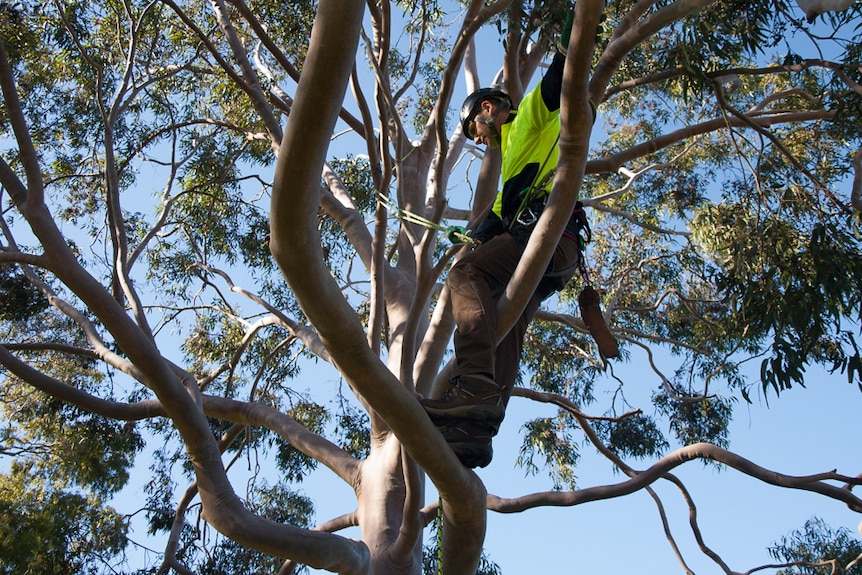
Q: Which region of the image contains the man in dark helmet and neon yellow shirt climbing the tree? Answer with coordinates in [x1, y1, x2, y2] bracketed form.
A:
[422, 15, 578, 467]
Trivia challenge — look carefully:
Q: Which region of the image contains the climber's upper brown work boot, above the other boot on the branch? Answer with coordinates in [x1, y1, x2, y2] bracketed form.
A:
[421, 373, 505, 426]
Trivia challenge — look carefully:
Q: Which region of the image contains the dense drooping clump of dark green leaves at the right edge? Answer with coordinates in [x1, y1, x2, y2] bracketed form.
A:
[694, 203, 862, 393]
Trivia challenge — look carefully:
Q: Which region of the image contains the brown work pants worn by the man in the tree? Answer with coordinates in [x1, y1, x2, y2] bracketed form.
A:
[447, 230, 578, 403]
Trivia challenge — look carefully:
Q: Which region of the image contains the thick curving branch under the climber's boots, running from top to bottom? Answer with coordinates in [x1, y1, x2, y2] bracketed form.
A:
[271, 0, 485, 575]
